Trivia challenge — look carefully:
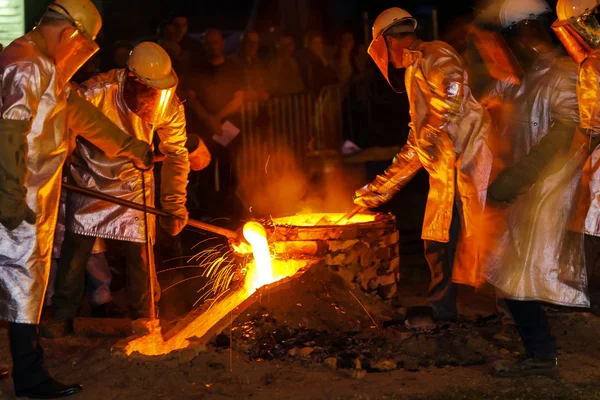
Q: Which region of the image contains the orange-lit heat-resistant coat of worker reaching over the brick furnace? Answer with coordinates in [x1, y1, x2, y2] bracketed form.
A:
[356, 41, 492, 244]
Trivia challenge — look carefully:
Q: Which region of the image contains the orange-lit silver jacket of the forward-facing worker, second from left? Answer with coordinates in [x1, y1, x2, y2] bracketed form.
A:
[66, 69, 189, 243]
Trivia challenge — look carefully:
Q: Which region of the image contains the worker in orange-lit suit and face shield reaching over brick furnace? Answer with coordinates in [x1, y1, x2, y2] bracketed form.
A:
[354, 8, 491, 321]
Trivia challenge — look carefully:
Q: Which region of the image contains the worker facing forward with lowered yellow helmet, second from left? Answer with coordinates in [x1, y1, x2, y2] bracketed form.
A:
[42, 42, 190, 337]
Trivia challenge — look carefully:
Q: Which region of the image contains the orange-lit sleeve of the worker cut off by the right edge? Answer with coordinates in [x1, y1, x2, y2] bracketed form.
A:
[577, 56, 600, 136]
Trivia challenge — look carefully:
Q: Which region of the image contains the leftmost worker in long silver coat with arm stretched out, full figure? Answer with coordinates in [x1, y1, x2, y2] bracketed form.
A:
[0, 0, 152, 398]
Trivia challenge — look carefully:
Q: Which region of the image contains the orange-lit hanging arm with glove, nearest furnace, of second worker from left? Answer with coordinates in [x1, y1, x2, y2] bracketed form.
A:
[157, 100, 190, 235]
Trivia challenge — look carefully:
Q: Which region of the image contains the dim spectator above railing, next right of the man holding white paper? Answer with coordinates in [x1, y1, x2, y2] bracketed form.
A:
[231, 31, 269, 100]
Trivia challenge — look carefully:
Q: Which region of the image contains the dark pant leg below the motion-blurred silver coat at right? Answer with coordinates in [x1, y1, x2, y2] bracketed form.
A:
[505, 299, 556, 360]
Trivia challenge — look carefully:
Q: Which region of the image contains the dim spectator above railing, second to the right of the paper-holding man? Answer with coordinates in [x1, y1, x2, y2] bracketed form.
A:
[267, 33, 306, 97]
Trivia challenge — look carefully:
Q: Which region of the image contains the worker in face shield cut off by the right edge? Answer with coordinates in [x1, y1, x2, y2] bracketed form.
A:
[552, 0, 600, 314]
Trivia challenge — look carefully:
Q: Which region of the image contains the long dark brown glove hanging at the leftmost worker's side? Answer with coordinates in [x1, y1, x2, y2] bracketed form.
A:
[0, 119, 36, 231]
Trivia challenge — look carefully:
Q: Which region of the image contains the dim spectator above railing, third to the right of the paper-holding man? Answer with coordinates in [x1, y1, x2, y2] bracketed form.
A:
[297, 32, 338, 96]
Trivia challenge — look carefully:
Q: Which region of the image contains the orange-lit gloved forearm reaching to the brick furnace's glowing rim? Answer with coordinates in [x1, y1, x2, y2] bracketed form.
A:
[354, 130, 423, 208]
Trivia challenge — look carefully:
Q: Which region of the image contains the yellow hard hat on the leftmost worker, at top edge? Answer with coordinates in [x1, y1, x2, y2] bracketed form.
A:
[48, 0, 102, 41]
